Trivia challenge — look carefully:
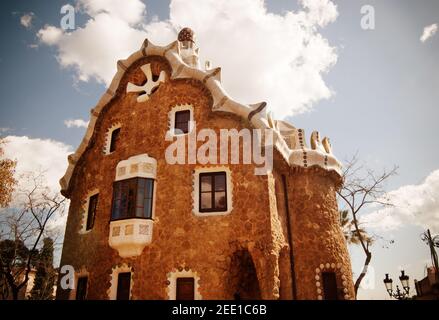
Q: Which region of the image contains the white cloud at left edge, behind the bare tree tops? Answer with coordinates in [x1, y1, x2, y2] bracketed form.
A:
[3, 136, 72, 191]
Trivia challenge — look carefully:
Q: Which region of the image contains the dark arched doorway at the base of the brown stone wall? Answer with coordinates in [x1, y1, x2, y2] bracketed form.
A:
[228, 249, 261, 300]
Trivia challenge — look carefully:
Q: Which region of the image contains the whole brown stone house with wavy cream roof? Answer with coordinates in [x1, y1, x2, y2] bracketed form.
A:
[57, 28, 354, 300]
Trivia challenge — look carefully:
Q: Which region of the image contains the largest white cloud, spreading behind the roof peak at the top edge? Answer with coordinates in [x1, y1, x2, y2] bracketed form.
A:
[38, 0, 337, 117]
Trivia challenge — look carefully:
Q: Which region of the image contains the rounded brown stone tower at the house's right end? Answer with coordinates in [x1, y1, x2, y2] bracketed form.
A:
[287, 167, 355, 300]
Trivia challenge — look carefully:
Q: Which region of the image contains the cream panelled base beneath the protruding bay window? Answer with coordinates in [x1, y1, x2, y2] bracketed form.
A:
[108, 218, 154, 258]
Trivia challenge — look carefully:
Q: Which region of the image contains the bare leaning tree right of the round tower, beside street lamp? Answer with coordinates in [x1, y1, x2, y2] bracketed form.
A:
[338, 155, 398, 295]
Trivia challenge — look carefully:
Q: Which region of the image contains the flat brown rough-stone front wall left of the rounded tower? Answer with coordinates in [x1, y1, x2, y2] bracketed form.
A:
[58, 57, 278, 299]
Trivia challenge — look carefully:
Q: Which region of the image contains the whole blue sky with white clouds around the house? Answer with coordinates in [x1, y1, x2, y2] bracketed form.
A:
[0, 0, 439, 299]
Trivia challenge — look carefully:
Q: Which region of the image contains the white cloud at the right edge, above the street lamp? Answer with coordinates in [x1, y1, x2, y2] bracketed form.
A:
[362, 170, 439, 232]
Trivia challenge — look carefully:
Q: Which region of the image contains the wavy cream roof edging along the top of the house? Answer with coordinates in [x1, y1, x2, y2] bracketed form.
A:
[60, 35, 341, 195]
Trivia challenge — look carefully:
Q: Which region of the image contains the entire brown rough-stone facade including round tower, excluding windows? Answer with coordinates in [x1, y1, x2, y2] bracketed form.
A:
[57, 29, 354, 299]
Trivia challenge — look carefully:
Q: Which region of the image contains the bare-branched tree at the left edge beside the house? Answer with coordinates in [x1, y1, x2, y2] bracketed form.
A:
[0, 173, 66, 300]
